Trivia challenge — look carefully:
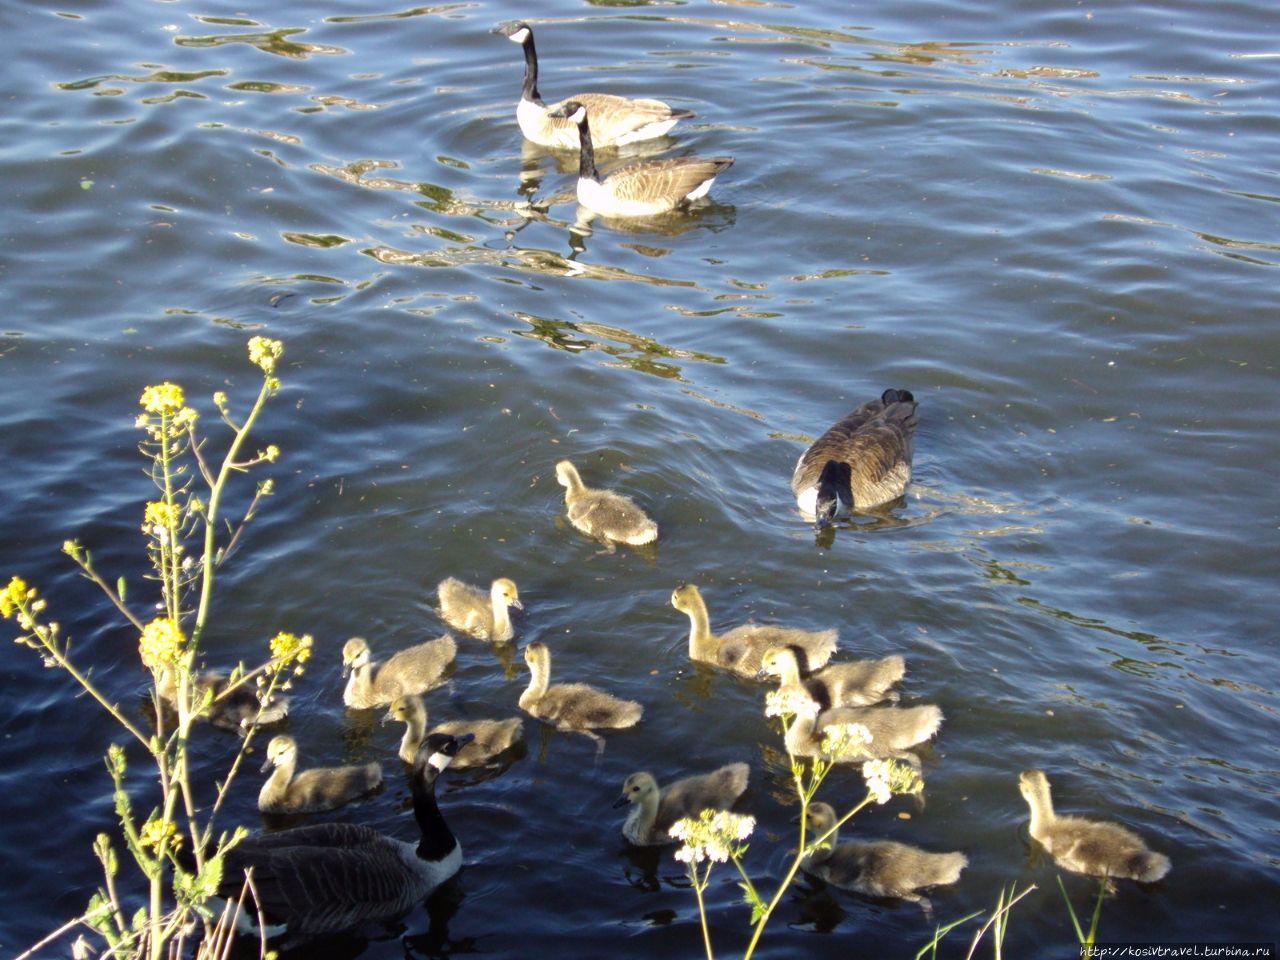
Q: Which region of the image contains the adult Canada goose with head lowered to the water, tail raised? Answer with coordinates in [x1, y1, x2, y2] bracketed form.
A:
[791, 390, 918, 529]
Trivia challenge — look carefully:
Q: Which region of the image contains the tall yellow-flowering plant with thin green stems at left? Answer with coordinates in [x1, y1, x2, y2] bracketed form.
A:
[0, 337, 304, 960]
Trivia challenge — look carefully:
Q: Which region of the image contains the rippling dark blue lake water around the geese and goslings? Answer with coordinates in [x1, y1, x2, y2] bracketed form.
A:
[0, 0, 1280, 960]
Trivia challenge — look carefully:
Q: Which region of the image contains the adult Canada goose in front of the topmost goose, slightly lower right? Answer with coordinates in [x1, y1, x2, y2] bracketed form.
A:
[548, 100, 733, 216]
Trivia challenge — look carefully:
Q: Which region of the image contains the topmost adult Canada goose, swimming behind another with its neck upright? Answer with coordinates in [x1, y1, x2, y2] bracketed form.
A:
[499, 22, 694, 150]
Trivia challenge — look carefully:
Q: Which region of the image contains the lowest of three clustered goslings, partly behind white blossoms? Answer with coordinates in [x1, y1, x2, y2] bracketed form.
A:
[786, 699, 942, 763]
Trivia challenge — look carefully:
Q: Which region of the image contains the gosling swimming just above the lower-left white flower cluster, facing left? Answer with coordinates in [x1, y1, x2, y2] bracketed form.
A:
[613, 763, 751, 846]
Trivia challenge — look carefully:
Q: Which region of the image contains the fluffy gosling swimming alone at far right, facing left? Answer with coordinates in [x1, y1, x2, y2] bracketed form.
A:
[1018, 771, 1170, 883]
